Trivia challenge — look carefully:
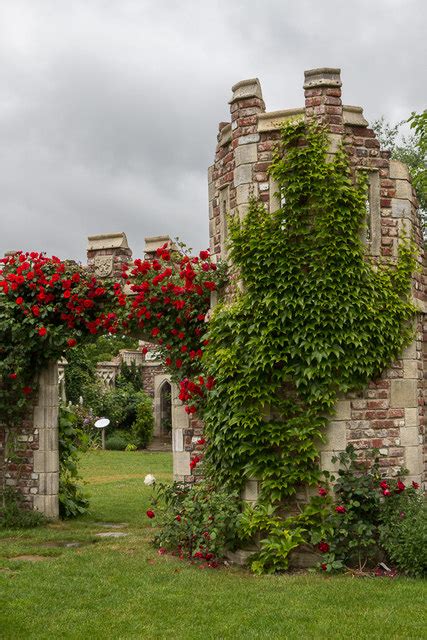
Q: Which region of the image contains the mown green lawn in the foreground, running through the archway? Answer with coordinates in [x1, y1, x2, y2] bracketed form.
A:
[0, 451, 427, 640]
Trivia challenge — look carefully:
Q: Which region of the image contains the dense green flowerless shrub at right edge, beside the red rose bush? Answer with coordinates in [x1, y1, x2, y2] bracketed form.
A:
[379, 488, 427, 577]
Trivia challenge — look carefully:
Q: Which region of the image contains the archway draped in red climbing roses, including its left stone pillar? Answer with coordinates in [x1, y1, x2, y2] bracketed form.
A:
[0, 234, 221, 517]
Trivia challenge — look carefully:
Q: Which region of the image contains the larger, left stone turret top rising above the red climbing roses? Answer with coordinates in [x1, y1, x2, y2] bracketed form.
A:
[87, 233, 132, 278]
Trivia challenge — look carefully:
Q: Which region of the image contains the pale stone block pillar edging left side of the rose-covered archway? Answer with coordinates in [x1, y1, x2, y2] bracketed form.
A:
[31, 362, 59, 518]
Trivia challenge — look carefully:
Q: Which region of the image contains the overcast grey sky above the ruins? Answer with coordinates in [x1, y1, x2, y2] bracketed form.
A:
[0, 0, 427, 260]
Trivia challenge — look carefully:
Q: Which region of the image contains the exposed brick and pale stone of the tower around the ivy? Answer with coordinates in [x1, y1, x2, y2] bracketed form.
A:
[208, 69, 427, 488]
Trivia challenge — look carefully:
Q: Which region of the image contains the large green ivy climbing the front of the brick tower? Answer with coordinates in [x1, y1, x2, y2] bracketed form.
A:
[204, 123, 415, 504]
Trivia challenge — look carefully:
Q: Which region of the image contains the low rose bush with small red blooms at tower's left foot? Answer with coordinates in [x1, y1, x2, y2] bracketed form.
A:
[147, 481, 239, 565]
